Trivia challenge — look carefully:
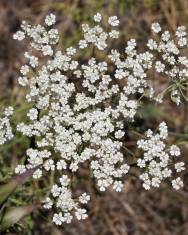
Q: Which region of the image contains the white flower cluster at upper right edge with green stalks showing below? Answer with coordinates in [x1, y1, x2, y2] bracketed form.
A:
[147, 23, 188, 105]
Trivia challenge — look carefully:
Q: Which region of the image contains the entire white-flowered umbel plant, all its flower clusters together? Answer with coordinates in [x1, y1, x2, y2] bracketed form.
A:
[0, 13, 188, 225]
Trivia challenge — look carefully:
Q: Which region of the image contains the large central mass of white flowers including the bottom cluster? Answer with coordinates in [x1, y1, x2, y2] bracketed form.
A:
[14, 13, 187, 225]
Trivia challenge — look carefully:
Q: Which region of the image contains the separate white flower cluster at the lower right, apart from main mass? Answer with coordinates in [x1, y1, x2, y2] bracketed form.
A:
[137, 122, 185, 190]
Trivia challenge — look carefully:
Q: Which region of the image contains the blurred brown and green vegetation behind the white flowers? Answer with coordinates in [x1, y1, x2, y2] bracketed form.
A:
[0, 0, 188, 235]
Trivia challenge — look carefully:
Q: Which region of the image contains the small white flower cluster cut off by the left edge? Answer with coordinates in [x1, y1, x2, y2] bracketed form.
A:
[0, 107, 13, 145]
